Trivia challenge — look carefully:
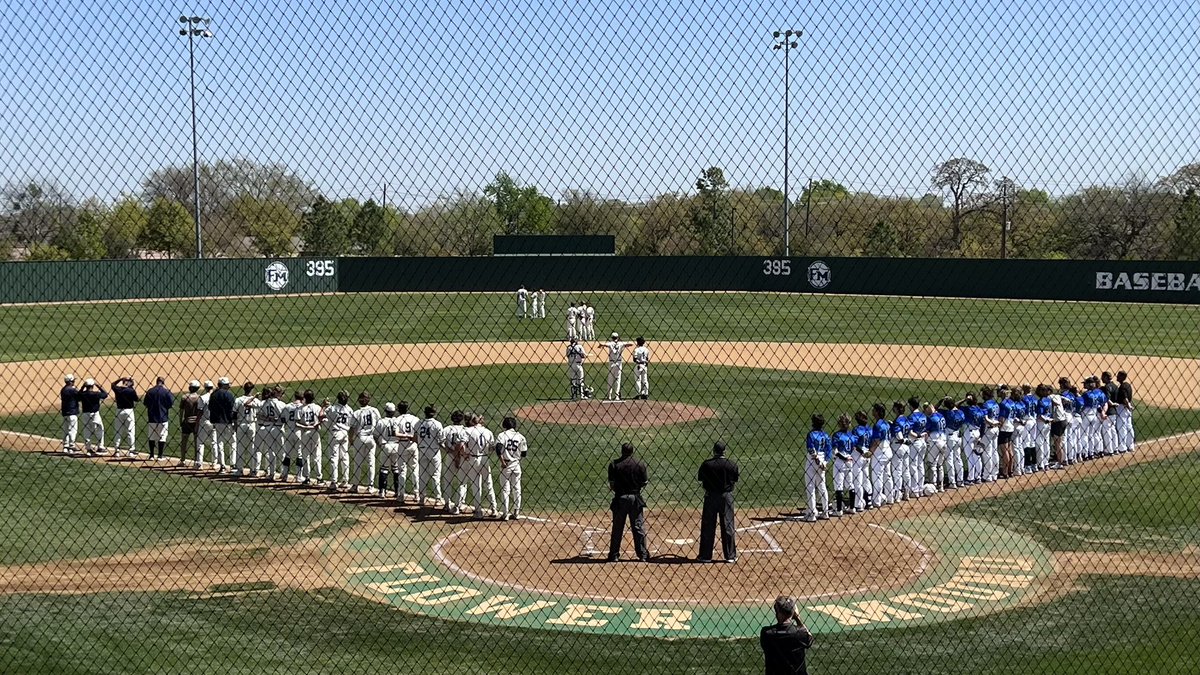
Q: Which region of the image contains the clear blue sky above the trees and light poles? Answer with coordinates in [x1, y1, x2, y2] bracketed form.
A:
[0, 0, 1200, 205]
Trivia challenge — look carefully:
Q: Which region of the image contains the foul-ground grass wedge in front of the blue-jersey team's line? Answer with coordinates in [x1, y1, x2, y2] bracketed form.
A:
[953, 453, 1200, 551]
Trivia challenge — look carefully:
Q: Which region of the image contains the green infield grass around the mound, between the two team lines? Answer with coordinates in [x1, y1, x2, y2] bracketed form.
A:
[0, 364, 1196, 513]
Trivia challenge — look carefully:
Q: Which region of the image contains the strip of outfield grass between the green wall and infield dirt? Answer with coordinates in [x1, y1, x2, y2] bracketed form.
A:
[0, 293, 1200, 360]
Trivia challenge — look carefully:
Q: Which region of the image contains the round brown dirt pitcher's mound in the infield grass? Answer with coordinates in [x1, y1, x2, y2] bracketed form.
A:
[517, 399, 716, 429]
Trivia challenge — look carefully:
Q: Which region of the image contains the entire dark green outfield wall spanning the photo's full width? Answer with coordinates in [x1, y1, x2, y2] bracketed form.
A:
[0, 256, 1200, 304]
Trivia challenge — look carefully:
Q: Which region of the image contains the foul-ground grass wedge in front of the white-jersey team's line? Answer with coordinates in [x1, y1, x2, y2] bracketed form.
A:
[0, 452, 356, 564]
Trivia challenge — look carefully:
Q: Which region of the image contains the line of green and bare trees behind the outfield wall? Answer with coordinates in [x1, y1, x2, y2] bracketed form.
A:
[0, 157, 1200, 261]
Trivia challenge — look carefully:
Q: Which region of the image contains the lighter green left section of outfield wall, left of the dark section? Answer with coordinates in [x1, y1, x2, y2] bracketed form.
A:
[0, 258, 337, 304]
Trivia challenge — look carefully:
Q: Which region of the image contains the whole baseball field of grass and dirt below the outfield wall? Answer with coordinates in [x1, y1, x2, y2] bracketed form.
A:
[0, 293, 1200, 673]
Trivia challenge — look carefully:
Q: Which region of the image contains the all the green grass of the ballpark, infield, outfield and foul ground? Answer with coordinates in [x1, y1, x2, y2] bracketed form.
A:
[0, 288, 1200, 674]
